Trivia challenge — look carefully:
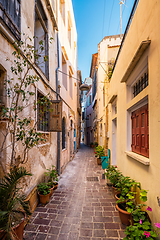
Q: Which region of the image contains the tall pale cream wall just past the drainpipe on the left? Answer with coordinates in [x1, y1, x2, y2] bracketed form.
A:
[58, 0, 79, 171]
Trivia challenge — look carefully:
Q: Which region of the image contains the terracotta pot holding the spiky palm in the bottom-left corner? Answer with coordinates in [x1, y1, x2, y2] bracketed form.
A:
[0, 213, 26, 240]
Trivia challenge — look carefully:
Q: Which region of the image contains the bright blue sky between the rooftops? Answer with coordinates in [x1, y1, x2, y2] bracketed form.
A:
[72, 0, 134, 81]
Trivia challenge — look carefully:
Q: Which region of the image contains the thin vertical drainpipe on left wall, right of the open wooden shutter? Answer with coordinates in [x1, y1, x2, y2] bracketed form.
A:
[56, 32, 61, 175]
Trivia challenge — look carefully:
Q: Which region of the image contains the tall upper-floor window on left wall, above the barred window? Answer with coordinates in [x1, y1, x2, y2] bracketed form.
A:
[35, 0, 49, 78]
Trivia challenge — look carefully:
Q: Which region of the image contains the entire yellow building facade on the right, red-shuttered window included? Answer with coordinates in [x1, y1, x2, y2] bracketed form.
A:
[108, 0, 160, 222]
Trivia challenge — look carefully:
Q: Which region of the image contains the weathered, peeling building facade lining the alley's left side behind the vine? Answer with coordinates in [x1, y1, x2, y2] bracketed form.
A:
[0, 0, 81, 209]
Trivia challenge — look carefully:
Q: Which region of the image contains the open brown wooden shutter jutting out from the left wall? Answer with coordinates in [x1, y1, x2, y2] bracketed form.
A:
[49, 100, 62, 132]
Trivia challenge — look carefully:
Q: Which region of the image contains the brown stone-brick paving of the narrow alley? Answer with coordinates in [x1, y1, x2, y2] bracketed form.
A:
[24, 145, 125, 240]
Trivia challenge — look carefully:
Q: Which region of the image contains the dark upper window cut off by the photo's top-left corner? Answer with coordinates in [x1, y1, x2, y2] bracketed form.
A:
[0, 0, 21, 40]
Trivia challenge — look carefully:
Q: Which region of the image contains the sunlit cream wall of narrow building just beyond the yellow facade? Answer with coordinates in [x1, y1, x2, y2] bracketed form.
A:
[97, 35, 121, 148]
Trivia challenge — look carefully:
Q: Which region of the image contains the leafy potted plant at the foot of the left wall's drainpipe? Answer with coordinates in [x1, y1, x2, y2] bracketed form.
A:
[44, 165, 58, 196]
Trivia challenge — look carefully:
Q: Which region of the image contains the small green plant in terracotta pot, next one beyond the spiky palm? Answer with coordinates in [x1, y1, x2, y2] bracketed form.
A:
[37, 182, 50, 204]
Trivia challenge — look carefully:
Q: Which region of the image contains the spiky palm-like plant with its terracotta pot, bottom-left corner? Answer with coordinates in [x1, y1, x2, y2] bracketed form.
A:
[0, 167, 32, 240]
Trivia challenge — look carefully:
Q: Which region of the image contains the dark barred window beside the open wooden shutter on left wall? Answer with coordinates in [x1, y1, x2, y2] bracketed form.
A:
[37, 92, 50, 132]
